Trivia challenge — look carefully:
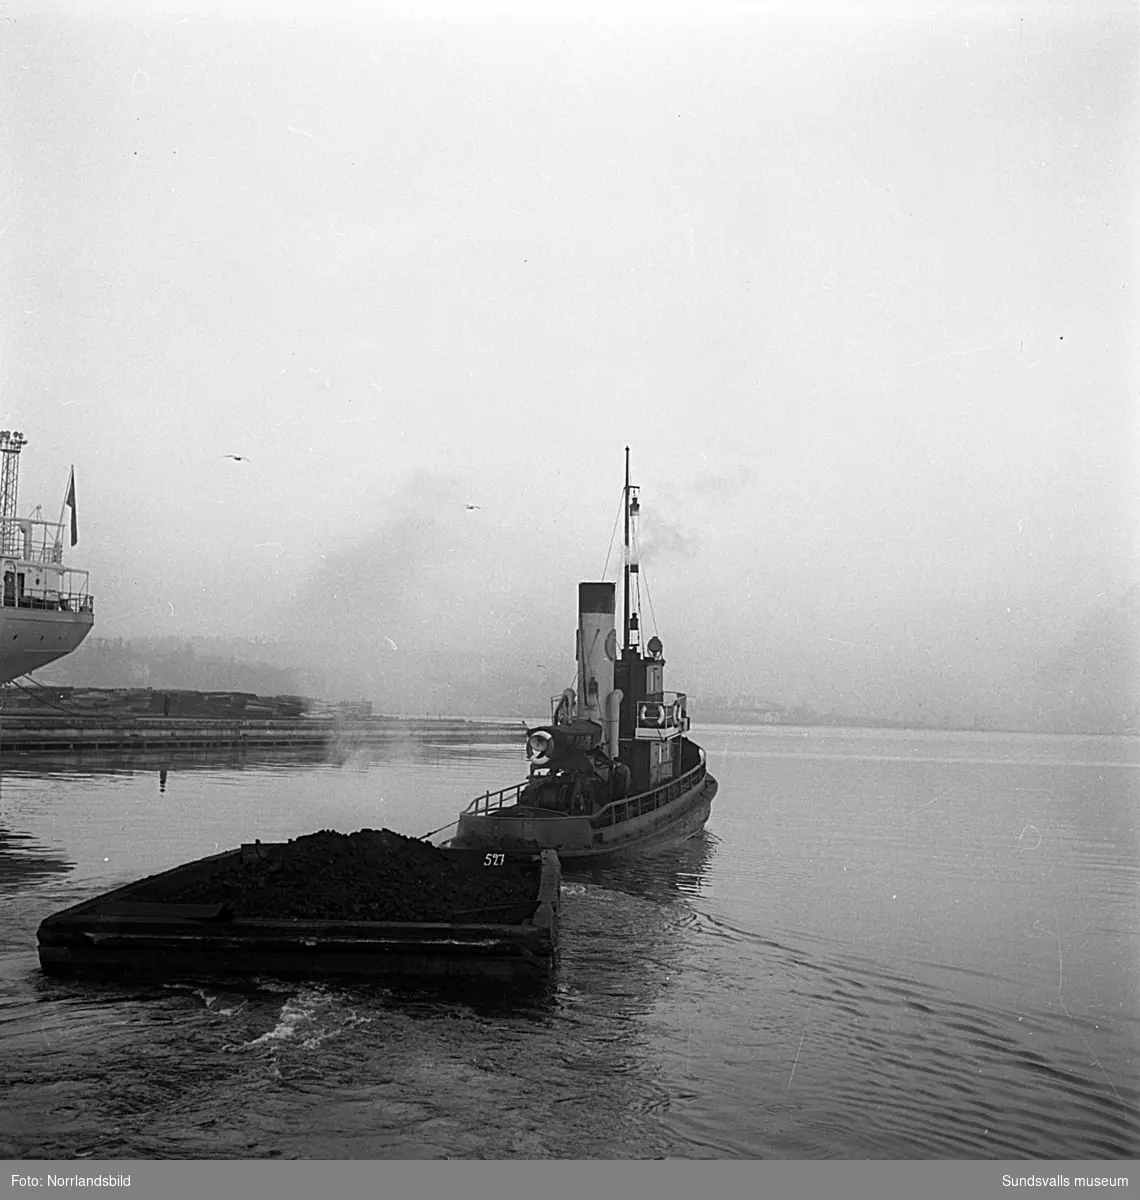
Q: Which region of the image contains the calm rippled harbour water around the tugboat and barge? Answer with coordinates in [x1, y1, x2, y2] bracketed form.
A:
[0, 727, 1140, 1159]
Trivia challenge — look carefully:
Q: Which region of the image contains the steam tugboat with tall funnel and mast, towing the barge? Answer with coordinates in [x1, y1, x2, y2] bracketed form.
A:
[450, 446, 716, 865]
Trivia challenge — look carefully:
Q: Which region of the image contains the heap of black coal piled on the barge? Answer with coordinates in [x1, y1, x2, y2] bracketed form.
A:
[134, 829, 538, 923]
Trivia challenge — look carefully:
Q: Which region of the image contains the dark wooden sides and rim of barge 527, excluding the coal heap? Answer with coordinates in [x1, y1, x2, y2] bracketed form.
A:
[36, 846, 562, 983]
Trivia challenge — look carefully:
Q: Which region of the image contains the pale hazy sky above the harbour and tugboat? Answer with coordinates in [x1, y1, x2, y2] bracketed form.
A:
[0, 0, 1140, 715]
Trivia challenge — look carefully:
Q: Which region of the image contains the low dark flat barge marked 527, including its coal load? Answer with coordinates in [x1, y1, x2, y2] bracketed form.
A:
[37, 830, 560, 984]
